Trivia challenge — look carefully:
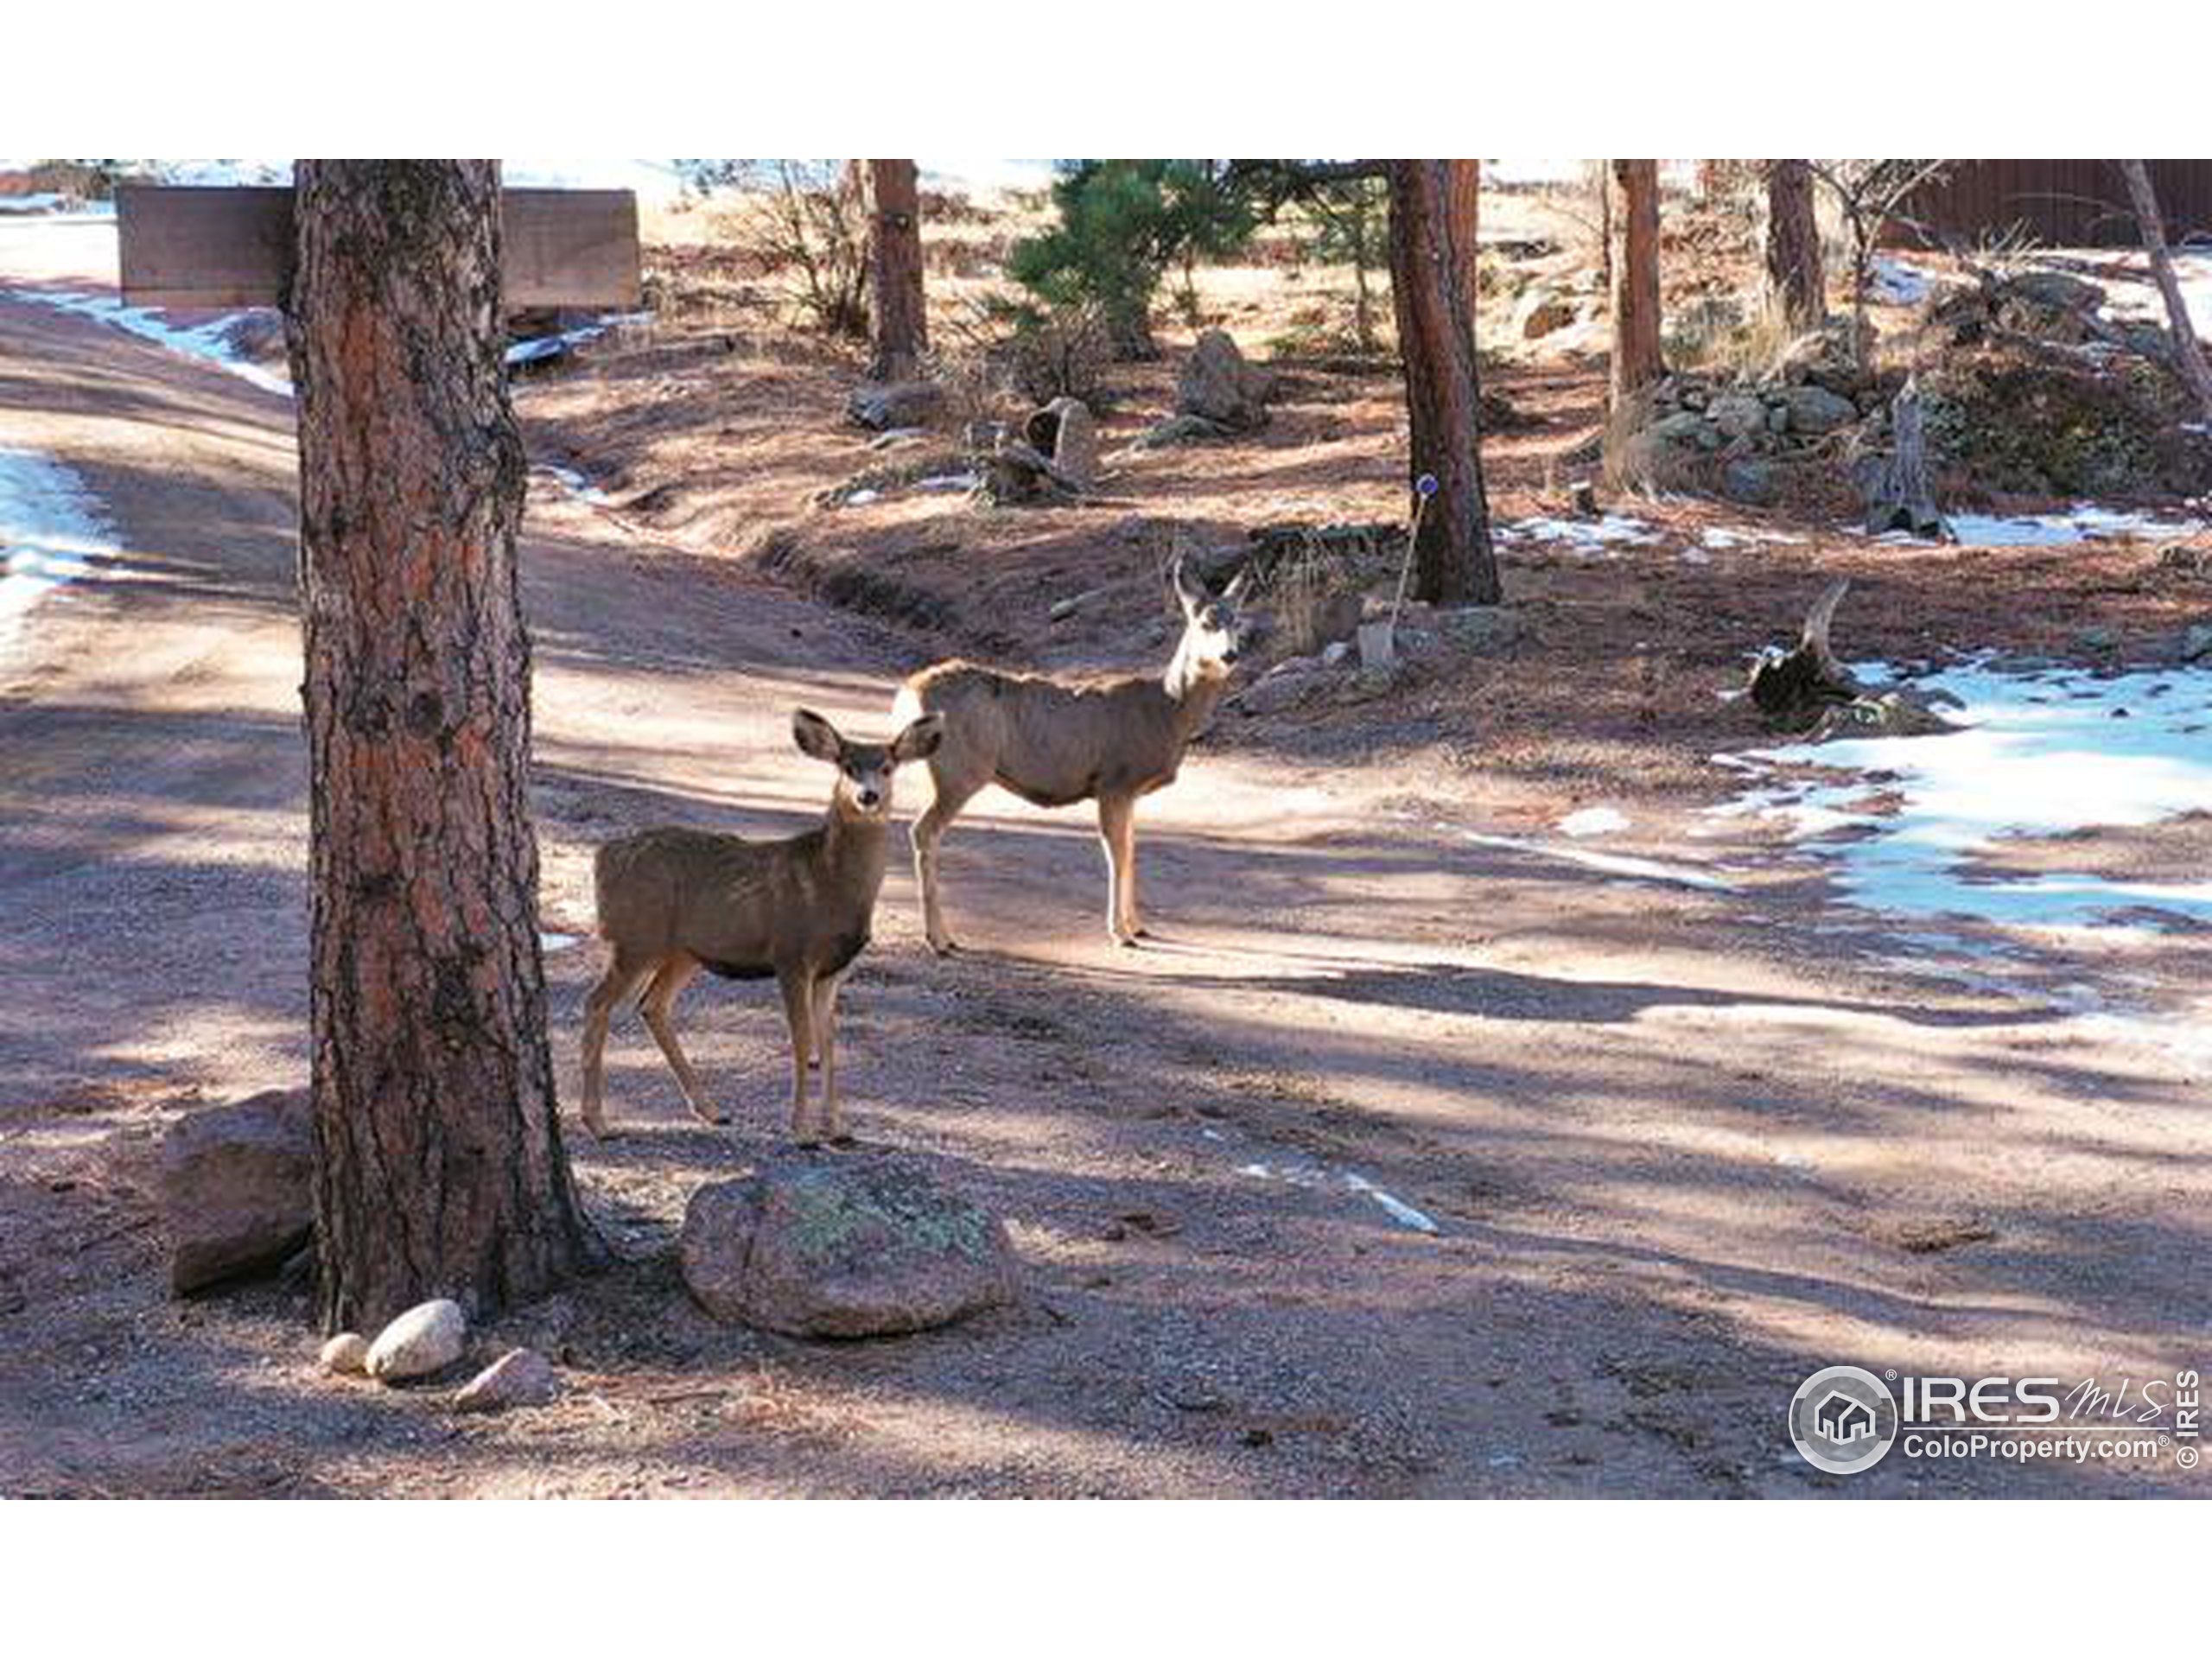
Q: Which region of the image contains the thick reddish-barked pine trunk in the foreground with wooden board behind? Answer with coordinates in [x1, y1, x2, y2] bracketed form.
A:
[288, 162, 600, 1332]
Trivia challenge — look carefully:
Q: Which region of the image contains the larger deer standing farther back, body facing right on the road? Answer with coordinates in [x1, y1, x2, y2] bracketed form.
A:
[896, 560, 1249, 956]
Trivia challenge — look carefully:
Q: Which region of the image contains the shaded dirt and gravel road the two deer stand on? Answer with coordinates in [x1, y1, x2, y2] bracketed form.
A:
[0, 279, 2212, 1496]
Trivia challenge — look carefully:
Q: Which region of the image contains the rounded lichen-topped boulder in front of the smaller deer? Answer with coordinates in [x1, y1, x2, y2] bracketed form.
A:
[681, 1153, 1018, 1336]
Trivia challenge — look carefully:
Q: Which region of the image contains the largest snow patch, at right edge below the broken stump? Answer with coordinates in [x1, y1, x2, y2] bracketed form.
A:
[1712, 659, 2212, 929]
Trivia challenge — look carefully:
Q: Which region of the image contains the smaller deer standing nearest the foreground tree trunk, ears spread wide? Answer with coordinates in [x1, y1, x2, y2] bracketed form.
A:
[584, 708, 943, 1146]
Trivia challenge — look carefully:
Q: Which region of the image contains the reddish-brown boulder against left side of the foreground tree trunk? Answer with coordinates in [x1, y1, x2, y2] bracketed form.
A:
[159, 1089, 315, 1294]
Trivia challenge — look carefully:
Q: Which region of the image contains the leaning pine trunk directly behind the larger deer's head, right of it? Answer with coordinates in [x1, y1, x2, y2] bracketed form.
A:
[1389, 162, 1504, 604]
